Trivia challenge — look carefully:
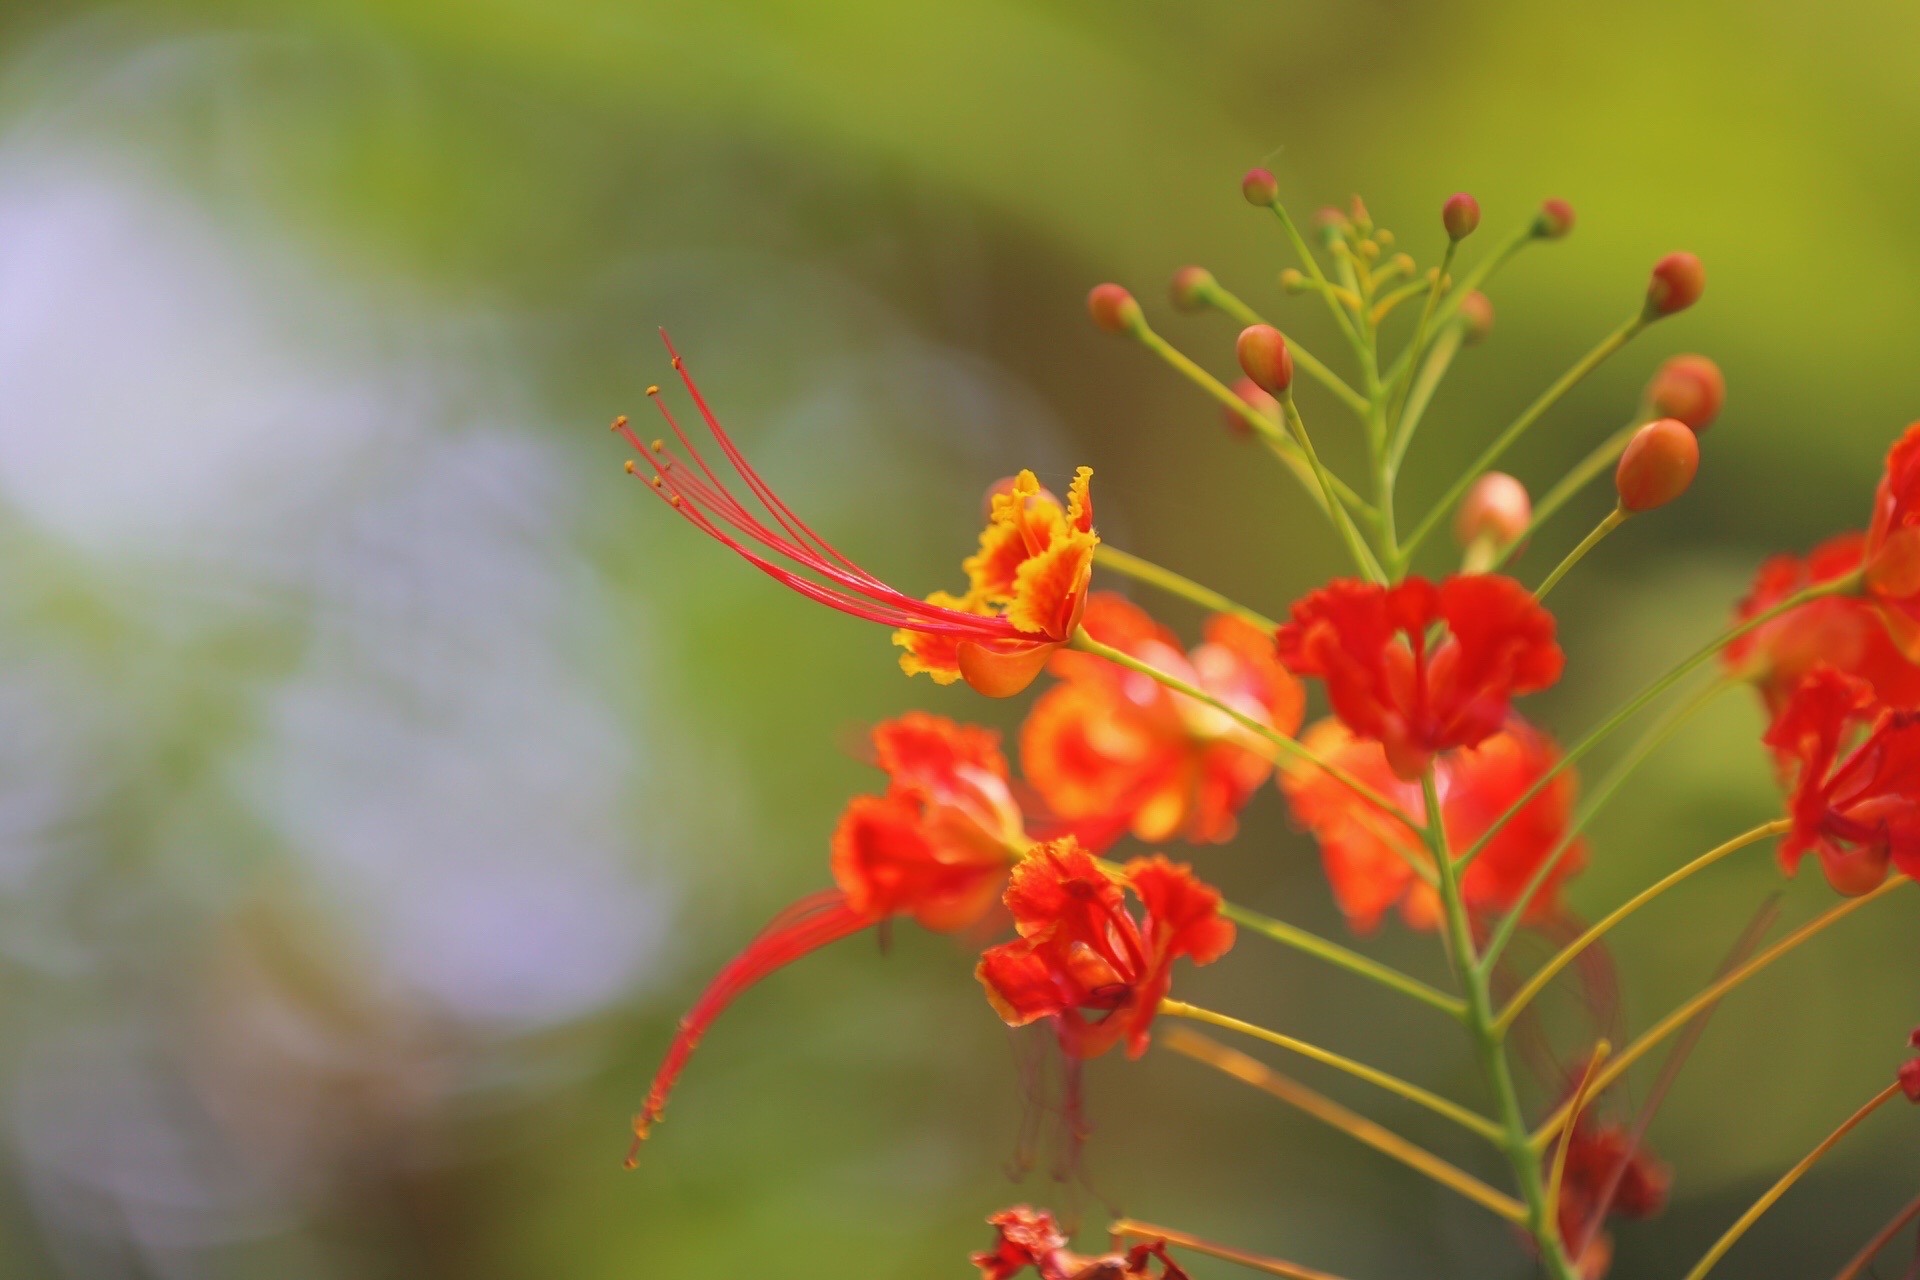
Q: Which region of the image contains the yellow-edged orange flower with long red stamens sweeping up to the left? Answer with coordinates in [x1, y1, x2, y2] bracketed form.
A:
[612, 342, 1098, 697]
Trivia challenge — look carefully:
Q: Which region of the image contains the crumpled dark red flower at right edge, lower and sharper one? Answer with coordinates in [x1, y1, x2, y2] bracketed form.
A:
[1766, 666, 1920, 894]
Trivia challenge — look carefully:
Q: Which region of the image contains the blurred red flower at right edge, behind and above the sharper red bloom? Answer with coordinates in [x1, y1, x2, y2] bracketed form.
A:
[1726, 533, 1920, 718]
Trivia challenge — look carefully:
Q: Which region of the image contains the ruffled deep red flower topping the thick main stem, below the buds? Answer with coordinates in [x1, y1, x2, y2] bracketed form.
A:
[1279, 574, 1565, 779]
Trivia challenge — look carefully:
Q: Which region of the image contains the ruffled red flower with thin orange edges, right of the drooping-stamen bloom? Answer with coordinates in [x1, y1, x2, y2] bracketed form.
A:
[975, 837, 1233, 1059]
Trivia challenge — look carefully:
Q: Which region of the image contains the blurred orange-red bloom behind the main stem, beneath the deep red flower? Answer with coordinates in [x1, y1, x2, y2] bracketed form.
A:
[1281, 718, 1586, 933]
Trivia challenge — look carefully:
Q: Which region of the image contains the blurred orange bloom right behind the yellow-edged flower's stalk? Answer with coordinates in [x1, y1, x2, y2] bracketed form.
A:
[1020, 591, 1304, 848]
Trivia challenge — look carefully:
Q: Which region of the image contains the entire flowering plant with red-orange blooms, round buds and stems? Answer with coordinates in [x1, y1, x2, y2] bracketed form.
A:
[614, 169, 1920, 1280]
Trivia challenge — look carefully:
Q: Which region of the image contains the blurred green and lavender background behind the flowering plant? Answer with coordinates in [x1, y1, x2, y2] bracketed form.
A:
[0, 0, 1920, 1280]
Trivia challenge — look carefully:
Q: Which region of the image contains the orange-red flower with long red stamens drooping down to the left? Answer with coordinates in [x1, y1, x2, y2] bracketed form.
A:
[634, 712, 1027, 1146]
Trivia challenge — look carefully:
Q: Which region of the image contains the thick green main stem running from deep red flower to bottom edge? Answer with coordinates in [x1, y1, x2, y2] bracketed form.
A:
[1421, 768, 1578, 1280]
